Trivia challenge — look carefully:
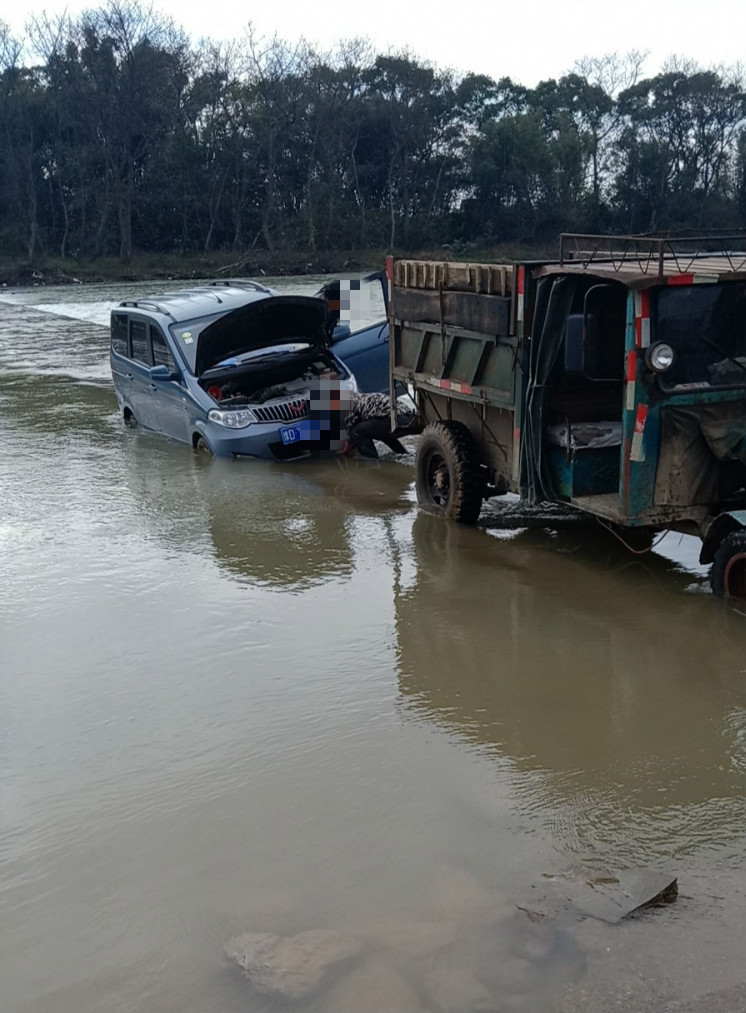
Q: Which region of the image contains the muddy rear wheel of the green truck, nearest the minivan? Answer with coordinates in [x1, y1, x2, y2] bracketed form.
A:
[415, 421, 484, 524]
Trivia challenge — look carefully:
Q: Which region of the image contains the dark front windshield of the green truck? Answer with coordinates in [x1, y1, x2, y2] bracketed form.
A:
[654, 282, 746, 390]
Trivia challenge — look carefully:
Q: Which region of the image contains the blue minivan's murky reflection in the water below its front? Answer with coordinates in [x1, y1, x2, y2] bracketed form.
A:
[120, 445, 412, 592]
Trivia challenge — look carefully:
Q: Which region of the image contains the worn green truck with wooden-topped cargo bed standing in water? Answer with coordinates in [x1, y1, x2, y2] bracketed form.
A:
[387, 234, 746, 597]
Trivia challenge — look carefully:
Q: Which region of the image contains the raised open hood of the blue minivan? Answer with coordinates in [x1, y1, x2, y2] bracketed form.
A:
[195, 296, 329, 376]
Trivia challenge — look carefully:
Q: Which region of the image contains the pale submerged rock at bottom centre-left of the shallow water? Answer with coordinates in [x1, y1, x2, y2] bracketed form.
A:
[225, 929, 361, 1001]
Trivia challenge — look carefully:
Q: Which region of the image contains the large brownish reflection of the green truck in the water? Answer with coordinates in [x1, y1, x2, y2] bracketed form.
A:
[395, 515, 746, 864]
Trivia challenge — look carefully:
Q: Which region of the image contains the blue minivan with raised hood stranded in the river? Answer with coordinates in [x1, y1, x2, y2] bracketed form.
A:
[110, 281, 364, 460]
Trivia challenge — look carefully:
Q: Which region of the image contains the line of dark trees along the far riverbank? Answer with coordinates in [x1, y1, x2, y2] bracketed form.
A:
[0, 0, 746, 262]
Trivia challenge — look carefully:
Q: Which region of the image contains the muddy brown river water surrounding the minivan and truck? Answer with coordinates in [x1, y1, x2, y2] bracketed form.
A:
[0, 283, 746, 1013]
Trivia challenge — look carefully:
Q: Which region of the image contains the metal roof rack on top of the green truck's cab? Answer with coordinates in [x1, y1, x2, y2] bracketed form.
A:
[560, 231, 746, 279]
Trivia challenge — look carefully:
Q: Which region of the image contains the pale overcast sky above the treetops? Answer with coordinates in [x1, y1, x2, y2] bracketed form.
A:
[5, 0, 746, 86]
